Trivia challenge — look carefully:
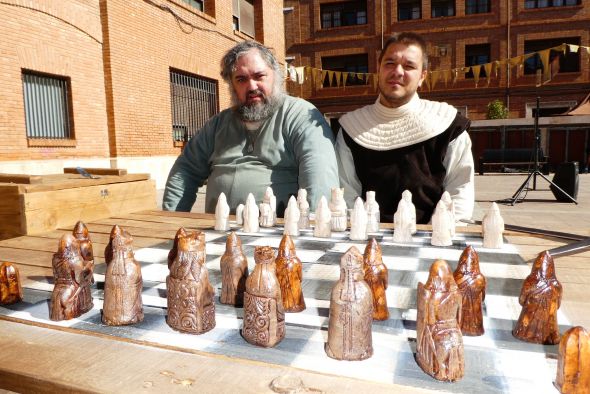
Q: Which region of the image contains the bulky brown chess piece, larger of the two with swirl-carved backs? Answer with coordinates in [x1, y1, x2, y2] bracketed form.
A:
[166, 231, 215, 334]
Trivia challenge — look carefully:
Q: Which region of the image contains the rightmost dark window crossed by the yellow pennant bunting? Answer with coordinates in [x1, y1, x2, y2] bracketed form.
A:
[524, 37, 580, 74]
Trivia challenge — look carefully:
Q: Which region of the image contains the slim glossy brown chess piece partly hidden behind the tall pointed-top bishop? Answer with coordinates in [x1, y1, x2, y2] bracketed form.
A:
[363, 238, 389, 320]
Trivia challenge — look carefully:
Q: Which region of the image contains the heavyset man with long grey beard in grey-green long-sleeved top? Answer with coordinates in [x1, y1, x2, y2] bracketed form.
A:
[162, 41, 338, 216]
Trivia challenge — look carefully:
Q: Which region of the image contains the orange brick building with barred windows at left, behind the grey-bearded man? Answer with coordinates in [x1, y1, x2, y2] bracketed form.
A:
[0, 0, 285, 187]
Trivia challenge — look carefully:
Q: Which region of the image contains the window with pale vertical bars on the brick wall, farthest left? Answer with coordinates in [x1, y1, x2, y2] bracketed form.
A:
[22, 71, 72, 139]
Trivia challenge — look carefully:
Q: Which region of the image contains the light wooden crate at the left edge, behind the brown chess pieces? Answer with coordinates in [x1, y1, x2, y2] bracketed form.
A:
[0, 173, 156, 239]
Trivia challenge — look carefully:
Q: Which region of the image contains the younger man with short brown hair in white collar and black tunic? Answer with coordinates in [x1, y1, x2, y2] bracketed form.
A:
[336, 33, 474, 223]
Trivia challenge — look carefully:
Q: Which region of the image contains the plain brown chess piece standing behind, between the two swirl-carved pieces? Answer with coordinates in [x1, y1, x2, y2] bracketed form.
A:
[219, 231, 248, 307]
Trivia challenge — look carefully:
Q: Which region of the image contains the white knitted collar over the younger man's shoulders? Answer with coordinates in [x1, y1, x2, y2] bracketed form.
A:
[340, 93, 457, 151]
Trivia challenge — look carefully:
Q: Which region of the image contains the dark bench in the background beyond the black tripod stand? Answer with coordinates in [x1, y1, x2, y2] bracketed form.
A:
[479, 148, 549, 175]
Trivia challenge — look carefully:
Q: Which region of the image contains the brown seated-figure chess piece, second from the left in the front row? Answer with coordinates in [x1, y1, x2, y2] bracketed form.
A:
[49, 234, 92, 320]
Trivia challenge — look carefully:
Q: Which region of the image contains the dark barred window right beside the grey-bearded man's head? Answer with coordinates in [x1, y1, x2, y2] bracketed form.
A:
[170, 70, 218, 141]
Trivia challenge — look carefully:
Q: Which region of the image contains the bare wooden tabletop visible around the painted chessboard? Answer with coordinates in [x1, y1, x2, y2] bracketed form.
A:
[0, 211, 590, 393]
